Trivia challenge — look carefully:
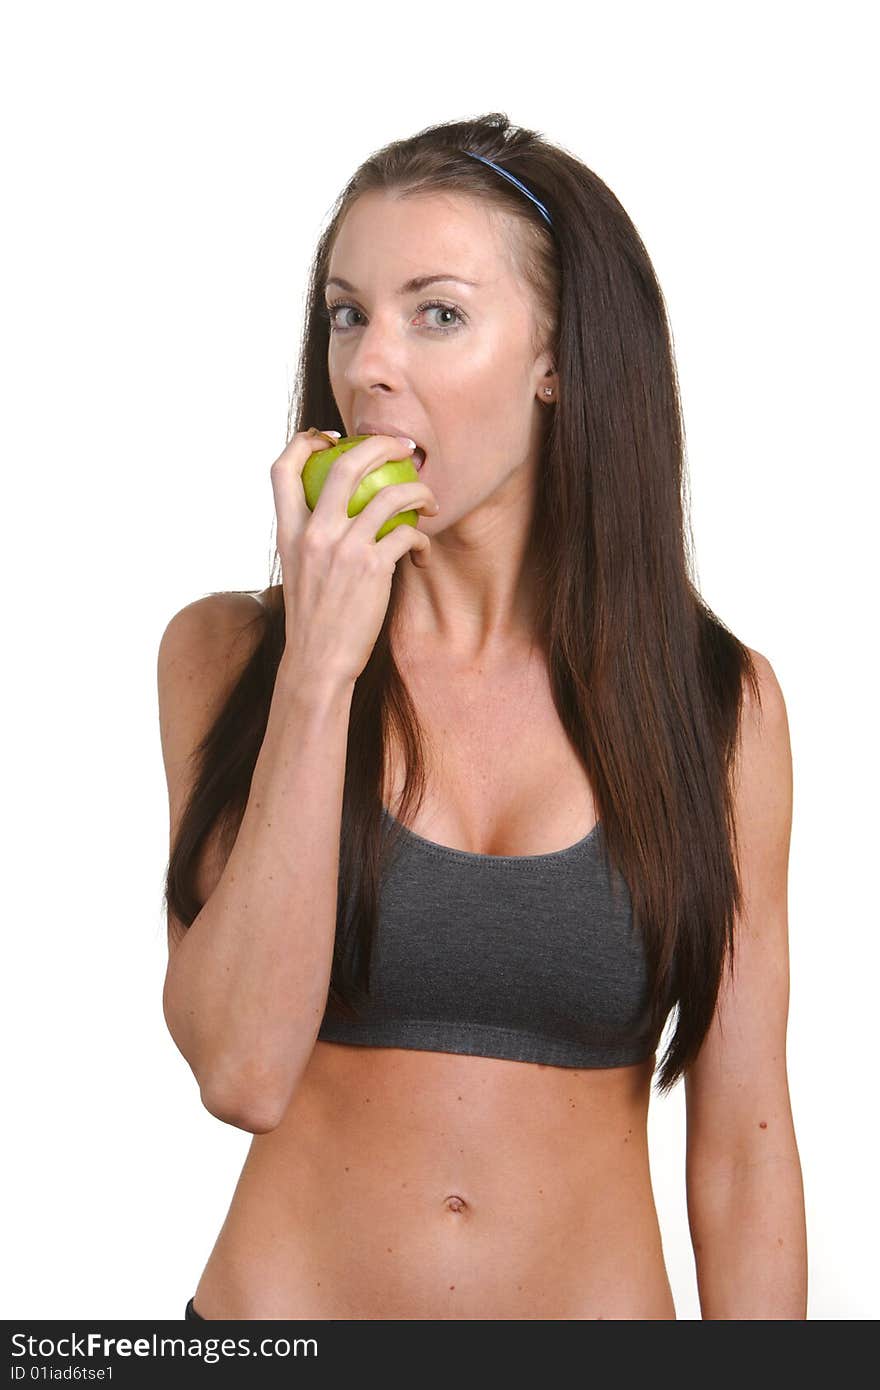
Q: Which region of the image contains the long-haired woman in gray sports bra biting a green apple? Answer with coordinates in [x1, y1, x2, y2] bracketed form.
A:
[158, 114, 806, 1319]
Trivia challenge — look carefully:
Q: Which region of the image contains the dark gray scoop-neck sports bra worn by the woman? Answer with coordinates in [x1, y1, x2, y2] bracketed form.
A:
[318, 808, 658, 1068]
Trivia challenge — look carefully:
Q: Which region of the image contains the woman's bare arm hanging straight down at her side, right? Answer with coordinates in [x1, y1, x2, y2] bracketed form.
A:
[685, 652, 806, 1319]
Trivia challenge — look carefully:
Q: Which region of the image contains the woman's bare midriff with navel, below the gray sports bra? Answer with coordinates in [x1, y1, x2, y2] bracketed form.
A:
[193, 1043, 676, 1321]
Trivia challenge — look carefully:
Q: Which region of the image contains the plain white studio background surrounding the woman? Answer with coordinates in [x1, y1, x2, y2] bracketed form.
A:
[0, 0, 880, 1319]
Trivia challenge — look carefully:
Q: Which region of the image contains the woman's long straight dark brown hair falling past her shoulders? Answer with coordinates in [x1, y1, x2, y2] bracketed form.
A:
[165, 113, 760, 1094]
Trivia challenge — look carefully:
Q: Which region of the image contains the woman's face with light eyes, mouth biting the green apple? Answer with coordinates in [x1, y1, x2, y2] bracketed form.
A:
[325, 192, 551, 532]
